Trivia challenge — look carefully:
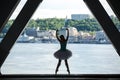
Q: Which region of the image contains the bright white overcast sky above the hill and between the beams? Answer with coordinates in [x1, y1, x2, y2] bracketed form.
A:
[11, 0, 113, 19]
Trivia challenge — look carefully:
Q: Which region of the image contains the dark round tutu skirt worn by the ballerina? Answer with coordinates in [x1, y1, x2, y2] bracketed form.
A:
[54, 49, 72, 60]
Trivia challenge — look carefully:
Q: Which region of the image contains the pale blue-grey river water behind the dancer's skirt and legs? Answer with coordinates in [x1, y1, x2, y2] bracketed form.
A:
[1, 43, 120, 74]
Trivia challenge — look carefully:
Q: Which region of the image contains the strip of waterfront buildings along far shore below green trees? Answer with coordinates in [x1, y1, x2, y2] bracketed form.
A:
[17, 27, 110, 43]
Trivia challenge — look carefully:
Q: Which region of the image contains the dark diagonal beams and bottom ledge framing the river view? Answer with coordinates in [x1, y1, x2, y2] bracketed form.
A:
[0, 0, 120, 80]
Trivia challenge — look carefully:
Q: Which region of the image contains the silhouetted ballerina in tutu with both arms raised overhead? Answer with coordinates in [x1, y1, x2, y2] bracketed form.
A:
[54, 28, 72, 74]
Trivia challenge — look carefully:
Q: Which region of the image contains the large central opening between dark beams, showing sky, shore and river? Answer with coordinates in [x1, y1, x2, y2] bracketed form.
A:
[1, 0, 120, 74]
